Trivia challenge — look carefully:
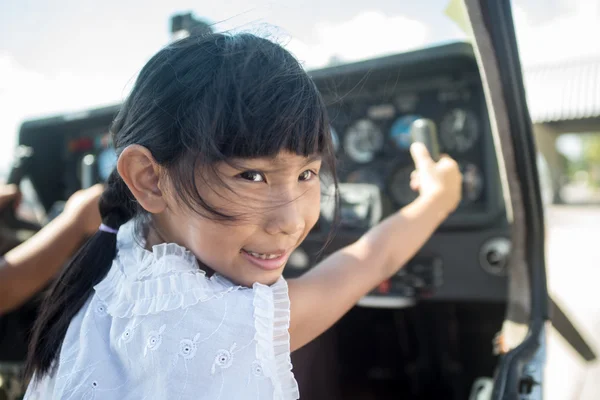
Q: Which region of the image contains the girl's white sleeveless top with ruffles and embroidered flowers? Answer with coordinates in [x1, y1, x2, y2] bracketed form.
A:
[25, 222, 299, 400]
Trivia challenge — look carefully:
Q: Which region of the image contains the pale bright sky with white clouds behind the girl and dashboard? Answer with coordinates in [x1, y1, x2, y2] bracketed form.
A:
[0, 0, 600, 170]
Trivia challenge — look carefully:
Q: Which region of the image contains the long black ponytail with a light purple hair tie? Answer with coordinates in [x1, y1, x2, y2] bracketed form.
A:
[25, 169, 137, 379]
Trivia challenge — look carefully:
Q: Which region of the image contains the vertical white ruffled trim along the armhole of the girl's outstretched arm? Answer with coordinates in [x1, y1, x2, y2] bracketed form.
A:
[253, 278, 300, 400]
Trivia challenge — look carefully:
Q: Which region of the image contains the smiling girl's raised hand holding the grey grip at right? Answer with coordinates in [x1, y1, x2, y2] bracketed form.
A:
[410, 143, 462, 214]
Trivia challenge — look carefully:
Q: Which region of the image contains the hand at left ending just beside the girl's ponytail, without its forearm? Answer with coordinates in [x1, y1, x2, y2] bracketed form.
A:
[64, 185, 104, 237]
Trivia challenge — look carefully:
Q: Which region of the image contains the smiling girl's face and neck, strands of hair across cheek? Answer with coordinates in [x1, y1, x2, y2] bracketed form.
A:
[155, 152, 321, 286]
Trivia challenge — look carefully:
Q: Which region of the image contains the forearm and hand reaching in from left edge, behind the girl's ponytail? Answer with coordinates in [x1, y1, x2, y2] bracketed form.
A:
[0, 185, 103, 315]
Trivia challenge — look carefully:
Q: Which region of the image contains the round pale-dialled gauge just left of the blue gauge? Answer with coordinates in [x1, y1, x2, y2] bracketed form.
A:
[344, 119, 383, 164]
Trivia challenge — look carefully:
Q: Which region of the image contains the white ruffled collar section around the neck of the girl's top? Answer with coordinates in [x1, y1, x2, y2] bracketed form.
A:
[94, 221, 241, 318]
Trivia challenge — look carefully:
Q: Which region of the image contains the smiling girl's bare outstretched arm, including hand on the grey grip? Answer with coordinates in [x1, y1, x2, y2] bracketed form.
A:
[289, 144, 462, 351]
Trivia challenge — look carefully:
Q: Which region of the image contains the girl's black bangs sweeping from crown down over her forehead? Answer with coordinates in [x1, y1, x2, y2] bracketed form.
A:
[173, 34, 332, 164]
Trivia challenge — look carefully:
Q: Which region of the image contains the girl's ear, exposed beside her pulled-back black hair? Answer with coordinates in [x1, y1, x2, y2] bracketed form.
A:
[117, 144, 167, 214]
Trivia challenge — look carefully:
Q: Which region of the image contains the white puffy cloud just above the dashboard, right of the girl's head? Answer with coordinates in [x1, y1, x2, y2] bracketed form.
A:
[286, 11, 430, 68]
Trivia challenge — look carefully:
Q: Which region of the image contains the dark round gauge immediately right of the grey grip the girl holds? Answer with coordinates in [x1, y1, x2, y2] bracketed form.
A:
[440, 108, 479, 153]
